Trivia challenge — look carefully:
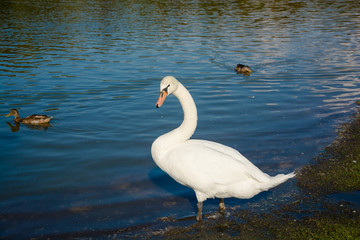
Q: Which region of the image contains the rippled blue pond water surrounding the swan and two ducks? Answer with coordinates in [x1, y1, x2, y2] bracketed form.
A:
[0, 0, 360, 239]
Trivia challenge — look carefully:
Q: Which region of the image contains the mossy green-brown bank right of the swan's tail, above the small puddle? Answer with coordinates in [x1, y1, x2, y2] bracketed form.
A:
[297, 113, 360, 194]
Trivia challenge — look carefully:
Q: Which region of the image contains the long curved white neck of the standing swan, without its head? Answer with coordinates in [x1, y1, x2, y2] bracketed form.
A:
[152, 83, 197, 159]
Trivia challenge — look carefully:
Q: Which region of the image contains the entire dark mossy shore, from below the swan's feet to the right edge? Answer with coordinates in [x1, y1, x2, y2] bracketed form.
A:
[142, 106, 360, 240]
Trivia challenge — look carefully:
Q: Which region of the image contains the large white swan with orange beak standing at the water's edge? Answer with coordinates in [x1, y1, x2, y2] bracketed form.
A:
[151, 76, 295, 221]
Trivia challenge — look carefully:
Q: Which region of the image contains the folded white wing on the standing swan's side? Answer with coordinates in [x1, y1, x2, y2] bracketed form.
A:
[165, 140, 269, 190]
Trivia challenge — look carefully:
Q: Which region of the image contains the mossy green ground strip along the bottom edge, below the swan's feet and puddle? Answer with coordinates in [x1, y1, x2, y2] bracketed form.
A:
[151, 202, 360, 240]
